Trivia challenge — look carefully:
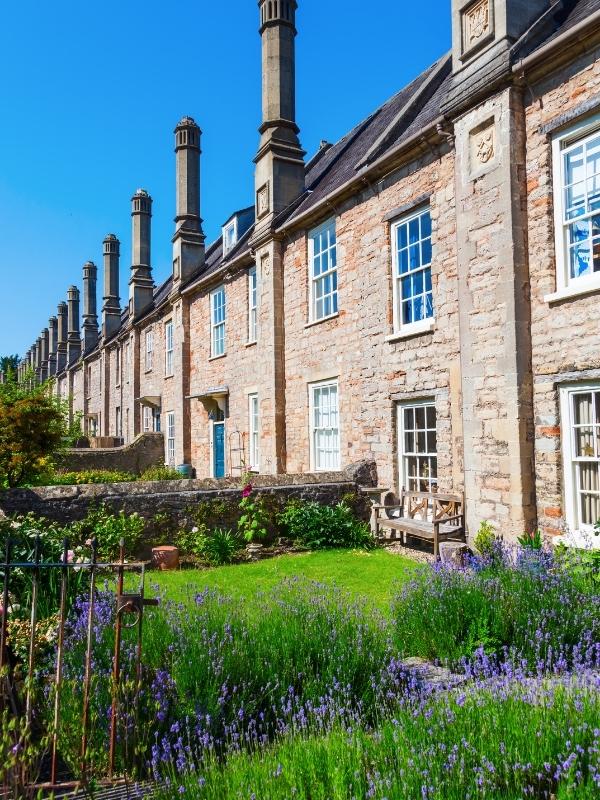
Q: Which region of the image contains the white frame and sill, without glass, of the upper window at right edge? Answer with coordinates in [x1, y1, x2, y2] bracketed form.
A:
[547, 114, 600, 300]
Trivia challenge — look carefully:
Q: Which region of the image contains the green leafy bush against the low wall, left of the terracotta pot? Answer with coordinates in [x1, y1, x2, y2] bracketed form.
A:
[71, 504, 145, 561]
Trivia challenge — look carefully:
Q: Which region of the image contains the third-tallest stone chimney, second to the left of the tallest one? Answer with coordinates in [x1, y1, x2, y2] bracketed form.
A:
[129, 189, 154, 320]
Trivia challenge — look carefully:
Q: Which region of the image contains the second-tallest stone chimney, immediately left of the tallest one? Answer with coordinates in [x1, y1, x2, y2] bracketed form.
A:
[173, 117, 205, 284]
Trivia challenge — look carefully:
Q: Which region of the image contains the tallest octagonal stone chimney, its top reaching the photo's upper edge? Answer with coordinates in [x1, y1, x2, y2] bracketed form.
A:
[254, 0, 305, 234]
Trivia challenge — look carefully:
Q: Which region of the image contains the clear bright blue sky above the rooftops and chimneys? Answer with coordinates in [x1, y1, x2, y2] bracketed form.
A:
[0, 0, 451, 355]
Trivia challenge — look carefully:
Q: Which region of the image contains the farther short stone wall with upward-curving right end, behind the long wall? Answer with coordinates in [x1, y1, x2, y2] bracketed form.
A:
[57, 433, 164, 476]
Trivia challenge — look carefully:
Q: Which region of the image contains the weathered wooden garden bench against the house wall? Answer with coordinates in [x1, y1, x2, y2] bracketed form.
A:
[373, 490, 465, 557]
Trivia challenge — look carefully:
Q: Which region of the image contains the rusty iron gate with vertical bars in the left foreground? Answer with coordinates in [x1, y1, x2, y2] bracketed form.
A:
[0, 534, 158, 798]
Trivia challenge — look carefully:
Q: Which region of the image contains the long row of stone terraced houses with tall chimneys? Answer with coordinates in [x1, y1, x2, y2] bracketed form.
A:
[11, 0, 600, 535]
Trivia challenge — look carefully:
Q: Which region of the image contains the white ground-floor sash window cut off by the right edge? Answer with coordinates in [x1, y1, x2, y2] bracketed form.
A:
[560, 384, 600, 531]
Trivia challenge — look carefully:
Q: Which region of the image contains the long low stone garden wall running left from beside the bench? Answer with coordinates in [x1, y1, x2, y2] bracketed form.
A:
[0, 461, 377, 555]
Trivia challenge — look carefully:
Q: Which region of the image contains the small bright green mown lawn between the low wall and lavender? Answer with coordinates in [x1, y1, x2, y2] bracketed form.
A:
[148, 550, 419, 610]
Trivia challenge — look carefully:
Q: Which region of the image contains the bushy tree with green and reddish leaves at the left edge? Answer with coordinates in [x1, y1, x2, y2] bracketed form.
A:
[0, 380, 66, 487]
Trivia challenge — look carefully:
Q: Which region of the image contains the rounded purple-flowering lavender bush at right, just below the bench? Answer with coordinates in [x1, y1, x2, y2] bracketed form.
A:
[393, 549, 600, 665]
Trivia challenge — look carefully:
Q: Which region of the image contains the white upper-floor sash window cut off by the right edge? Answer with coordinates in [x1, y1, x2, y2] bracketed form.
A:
[553, 115, 600, 291]
